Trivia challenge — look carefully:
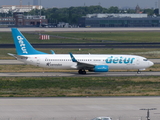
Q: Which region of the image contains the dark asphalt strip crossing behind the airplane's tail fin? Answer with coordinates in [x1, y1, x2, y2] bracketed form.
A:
[0, 42, 160, 49]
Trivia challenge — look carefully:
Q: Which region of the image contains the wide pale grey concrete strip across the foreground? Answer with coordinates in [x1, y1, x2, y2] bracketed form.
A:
[0, 97, 160, 120]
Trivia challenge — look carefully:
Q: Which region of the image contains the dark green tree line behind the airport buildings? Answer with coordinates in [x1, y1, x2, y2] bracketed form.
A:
[0, 5, 159, 24]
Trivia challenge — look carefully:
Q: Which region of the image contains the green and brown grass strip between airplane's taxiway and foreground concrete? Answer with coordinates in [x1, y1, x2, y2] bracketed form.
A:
[0, 77, 160, 97]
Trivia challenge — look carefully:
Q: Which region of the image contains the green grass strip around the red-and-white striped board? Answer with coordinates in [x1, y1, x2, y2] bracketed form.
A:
[0, 32, 160, 44]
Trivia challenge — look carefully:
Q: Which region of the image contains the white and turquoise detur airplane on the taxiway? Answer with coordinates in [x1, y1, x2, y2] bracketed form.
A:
[8, 28, 154, 74]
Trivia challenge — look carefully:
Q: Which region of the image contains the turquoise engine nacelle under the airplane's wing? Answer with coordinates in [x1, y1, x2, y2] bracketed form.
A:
[89, 65, 109, 72]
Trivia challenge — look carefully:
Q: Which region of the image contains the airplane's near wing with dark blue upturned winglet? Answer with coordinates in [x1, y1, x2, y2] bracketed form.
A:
[69, 53, 96, 69]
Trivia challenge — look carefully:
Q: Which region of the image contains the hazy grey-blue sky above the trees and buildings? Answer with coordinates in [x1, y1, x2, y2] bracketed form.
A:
[0, 0, 158, 8]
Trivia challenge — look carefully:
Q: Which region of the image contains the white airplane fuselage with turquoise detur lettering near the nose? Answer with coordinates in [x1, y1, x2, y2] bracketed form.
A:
[17, 54, 153, 70]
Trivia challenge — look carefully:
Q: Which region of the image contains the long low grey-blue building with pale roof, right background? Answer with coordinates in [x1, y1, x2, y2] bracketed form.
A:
[78, 14, 160, 27]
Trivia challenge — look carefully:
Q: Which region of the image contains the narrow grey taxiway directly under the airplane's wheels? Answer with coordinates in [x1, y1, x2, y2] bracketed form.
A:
[0, 71, 160, 77]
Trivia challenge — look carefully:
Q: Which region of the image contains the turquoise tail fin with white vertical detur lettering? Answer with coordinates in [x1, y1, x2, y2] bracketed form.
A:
[11, 28, 46, 55]
